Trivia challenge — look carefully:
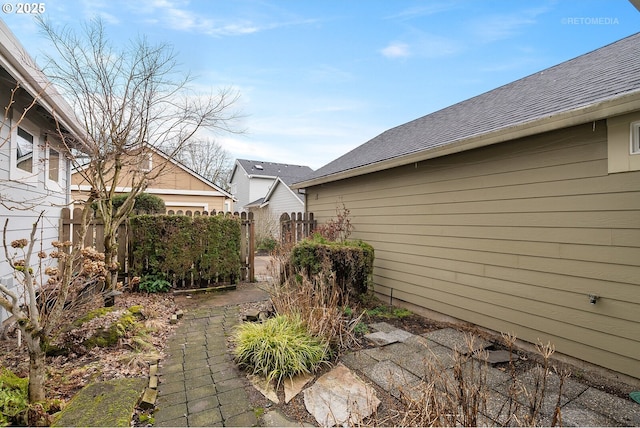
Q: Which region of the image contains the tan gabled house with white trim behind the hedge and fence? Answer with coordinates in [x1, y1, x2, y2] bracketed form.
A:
[71, 150, 233, 214]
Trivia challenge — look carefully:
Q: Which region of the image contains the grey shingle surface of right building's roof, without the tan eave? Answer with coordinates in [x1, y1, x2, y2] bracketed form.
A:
[300, 33, 640, 181]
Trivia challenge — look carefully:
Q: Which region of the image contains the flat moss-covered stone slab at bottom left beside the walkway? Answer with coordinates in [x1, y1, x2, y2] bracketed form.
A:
[52, 377, 147, 427]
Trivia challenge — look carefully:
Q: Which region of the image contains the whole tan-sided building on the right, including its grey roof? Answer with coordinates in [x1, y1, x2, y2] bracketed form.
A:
[294, 35, 640, 378]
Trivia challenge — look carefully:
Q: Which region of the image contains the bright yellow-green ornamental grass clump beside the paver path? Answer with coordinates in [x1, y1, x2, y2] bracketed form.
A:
[234, 315, 329, 383]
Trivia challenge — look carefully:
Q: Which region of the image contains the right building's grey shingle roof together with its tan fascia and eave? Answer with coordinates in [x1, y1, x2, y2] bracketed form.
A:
[293, 33, 640, 188]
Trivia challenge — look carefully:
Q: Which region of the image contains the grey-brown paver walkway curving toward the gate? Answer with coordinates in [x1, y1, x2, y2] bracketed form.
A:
[154, 288, 268, 426]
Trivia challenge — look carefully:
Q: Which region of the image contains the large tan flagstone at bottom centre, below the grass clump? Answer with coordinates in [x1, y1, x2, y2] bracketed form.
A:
[304, 364, 380, 427]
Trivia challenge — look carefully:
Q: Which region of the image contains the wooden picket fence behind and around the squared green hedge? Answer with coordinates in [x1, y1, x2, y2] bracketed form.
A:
[60, 208, 255, 281]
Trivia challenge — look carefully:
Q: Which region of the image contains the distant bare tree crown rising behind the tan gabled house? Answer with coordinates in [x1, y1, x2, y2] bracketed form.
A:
[171, 138, 233, 191]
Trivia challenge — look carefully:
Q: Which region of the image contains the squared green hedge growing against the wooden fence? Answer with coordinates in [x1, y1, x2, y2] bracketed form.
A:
[130, 215, 241, 288]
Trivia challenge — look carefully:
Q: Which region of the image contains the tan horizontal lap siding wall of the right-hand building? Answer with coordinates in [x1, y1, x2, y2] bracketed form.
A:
[307, 122, 640, 377]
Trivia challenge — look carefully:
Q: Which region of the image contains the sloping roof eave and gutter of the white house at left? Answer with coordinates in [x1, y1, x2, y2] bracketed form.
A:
[0, 20, 87, 149]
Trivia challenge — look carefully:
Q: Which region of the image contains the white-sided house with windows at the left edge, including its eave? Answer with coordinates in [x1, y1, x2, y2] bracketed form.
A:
[0, 20, 84, 319]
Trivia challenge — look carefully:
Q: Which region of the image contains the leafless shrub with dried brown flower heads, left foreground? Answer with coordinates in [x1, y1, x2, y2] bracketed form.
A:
[0, 212, 107, 403]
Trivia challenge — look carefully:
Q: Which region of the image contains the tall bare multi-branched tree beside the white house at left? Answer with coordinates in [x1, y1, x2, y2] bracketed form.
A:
[39, 18, 238, 289]
